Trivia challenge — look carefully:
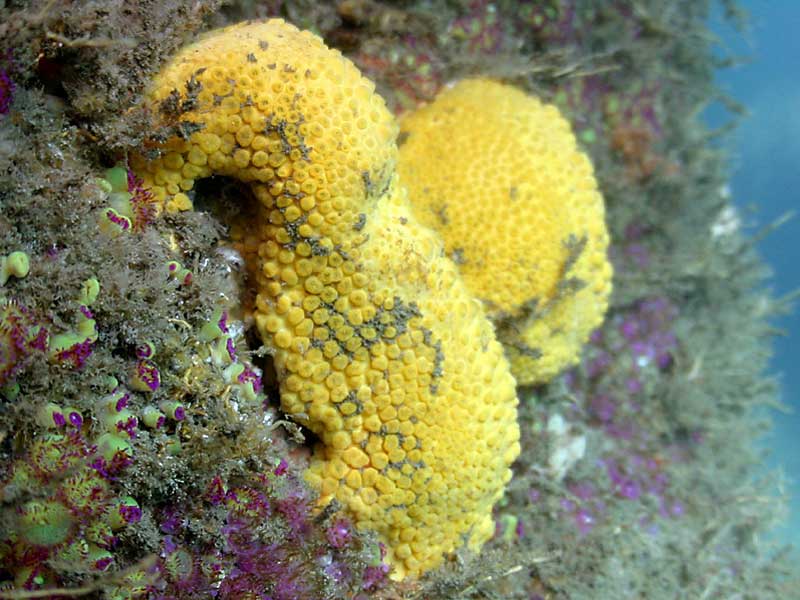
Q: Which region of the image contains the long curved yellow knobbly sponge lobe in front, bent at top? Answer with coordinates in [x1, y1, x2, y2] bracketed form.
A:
[133, 20, 519, 578]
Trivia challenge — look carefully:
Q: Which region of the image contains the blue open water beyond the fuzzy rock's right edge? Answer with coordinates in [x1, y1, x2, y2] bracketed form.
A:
[705, 0, 800, 554]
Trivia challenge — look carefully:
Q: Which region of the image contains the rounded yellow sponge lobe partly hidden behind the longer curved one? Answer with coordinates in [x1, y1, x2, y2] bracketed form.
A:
[398, 79, 612, 384]
